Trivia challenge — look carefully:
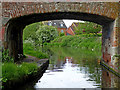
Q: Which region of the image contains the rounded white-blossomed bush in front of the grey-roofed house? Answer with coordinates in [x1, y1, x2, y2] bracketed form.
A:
[36, 25, 58, 44]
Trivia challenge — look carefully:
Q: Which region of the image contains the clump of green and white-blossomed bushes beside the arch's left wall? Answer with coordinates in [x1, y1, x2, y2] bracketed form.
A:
[23, 22, 58, 46]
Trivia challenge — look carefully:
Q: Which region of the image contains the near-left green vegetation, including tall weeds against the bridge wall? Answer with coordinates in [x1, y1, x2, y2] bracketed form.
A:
[1, 51, 38, 89]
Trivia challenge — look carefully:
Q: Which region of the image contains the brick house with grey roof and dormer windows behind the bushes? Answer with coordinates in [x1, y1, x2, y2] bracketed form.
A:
[44, 20, 67, 35]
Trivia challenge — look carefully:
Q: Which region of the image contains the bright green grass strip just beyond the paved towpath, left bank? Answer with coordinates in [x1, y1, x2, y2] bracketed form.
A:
[23, 43, 48, 59]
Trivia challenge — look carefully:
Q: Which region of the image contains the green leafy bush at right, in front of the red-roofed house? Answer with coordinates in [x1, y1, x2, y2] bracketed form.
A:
[74, 22, 102, 35]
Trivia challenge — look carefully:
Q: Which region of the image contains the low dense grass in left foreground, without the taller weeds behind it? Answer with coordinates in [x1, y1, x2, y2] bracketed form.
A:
[2, 62, 38, 82]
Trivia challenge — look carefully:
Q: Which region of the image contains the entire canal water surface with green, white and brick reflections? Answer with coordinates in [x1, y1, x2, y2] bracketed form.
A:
[19, 47, 120, 89]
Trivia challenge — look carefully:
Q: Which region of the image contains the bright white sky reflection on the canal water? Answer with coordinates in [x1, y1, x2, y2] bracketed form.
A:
[35, 58, 99, 88]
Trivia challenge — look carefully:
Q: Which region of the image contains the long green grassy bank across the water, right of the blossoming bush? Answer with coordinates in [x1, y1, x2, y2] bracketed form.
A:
[45, 35, 101, 49]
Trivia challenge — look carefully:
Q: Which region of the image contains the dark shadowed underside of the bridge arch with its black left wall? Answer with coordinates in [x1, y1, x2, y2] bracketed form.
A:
[5, 12, 114, 61]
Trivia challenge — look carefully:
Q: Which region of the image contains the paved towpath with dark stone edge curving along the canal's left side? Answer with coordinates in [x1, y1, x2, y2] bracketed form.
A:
[2, 56, 49, 90]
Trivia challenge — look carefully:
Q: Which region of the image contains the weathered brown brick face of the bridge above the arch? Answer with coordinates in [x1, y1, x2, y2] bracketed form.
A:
[2, 2, 118, 24]
